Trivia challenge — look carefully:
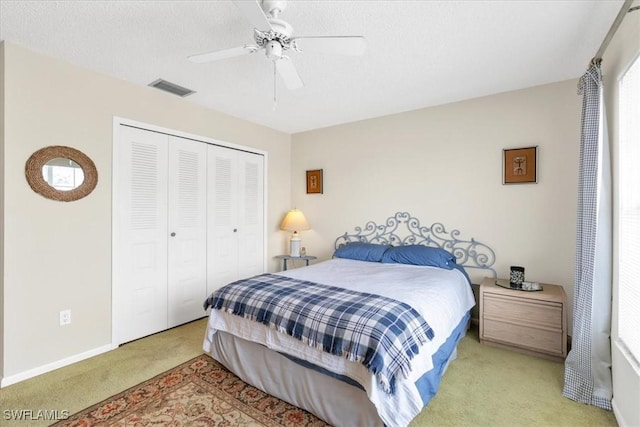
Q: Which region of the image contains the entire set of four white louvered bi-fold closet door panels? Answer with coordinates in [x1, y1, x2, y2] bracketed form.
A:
[113, 125, 264, 345]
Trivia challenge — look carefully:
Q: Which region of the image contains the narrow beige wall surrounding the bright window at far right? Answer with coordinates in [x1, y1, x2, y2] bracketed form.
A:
[602, 1, 640, 426]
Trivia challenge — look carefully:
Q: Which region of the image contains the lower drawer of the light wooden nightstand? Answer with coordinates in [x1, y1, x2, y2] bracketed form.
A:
[484, 317, 564, 356]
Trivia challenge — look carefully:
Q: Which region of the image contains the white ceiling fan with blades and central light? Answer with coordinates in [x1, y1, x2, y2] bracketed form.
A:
[189, 0, 367, 89]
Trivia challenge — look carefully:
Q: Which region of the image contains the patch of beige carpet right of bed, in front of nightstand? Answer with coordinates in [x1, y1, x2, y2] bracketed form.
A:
[411, 326, 618, 427]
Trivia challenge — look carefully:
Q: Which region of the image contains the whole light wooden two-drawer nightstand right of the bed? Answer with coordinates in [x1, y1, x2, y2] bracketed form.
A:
[479, 278, 567, 361]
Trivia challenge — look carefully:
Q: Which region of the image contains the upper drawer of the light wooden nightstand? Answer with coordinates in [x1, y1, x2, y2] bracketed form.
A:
[483, 293, 562, 328]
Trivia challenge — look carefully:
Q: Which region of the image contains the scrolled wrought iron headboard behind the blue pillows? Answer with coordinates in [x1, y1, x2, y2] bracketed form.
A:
[335, 212, 497, 277]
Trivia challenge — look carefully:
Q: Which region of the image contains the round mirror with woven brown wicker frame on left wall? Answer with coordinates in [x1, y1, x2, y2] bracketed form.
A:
[25, 145, 98, 202]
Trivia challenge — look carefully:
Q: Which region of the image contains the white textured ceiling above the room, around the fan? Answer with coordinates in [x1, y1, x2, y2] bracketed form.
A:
[0, 0, 622, 133]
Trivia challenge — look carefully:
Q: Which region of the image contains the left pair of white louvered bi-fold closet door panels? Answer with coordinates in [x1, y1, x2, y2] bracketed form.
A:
[113, 126, 207, 344]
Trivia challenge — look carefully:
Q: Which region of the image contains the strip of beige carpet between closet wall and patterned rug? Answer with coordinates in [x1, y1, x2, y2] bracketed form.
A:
[0, 319, 206, 427]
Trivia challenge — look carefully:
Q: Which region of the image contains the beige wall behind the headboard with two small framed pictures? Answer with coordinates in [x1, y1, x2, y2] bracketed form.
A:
[291, 80, 580, 323]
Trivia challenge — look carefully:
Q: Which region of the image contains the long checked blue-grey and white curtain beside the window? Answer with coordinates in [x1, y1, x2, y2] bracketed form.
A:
[562, 61, 612, 410]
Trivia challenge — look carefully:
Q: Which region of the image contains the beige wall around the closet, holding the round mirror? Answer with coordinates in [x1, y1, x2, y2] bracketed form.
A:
[0, 43, 291, 378]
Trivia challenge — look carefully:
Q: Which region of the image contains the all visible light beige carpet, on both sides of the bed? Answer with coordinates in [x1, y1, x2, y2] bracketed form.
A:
[0, 319, 617, 427]
